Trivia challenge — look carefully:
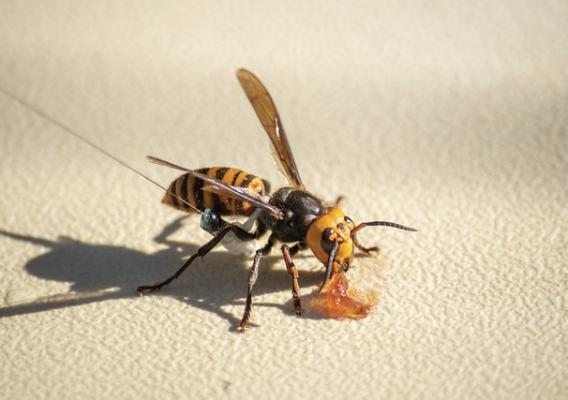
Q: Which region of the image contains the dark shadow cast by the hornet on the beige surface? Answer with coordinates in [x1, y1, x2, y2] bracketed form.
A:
[0, 216, 322, 330]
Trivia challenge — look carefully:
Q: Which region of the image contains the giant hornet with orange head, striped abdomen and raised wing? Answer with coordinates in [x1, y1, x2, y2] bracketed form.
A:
[138, 69, 415, 331]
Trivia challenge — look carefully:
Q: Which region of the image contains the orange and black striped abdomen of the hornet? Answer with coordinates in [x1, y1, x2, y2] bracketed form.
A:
[162, 167, 270, 215]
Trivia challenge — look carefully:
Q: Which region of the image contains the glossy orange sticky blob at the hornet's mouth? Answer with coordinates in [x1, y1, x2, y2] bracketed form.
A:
[310, 272, 379, 319]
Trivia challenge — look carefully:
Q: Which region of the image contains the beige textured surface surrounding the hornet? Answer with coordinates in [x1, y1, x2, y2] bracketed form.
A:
[0, 0, 568, 399]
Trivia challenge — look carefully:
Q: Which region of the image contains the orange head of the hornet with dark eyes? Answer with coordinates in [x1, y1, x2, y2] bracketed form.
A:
[306, 207, 355, 274]
